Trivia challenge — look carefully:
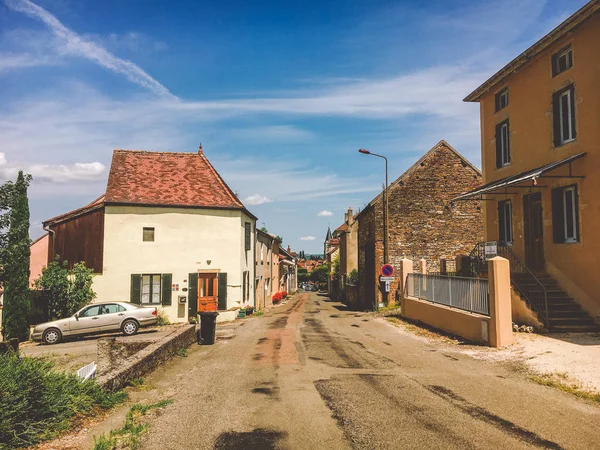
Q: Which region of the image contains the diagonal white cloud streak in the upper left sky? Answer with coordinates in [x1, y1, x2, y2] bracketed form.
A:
[5, 0, 176, 99]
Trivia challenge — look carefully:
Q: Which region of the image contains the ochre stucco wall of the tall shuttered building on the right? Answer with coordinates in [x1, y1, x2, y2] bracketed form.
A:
[480, 13, 600, 316]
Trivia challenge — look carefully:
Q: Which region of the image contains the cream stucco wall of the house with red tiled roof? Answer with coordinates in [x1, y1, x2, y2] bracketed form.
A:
[93, 206, 255, 321]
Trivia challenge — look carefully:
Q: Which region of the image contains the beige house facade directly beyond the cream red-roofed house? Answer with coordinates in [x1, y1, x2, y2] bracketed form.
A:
[254, 230, 279, 310]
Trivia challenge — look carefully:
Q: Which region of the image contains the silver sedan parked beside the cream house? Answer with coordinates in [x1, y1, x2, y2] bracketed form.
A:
[31, 302, 158, 344]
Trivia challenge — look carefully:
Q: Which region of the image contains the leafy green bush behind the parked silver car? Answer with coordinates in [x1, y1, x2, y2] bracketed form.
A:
[35, 255, 96, 320]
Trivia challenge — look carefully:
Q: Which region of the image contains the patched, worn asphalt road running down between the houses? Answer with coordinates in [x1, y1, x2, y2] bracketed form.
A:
[136, 293, 600, 449]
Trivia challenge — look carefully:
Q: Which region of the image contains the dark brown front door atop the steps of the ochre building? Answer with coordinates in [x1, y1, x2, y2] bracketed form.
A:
[523, 192, 546, 270]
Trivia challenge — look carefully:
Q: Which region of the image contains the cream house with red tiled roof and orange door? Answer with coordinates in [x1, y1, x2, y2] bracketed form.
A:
[44, 147, 256, 322]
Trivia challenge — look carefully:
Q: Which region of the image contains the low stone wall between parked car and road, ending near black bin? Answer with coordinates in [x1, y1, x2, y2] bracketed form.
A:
[98, 325, 196, 391]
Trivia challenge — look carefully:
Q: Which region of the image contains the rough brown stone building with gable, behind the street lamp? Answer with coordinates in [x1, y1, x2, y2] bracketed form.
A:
[357, 141, 483, 309]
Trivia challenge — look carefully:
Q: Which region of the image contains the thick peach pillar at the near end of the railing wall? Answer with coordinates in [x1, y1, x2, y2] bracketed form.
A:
[488, 256, 512, 347]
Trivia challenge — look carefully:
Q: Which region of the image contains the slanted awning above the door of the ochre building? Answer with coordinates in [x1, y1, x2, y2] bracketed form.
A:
[451, 153, 585, 202]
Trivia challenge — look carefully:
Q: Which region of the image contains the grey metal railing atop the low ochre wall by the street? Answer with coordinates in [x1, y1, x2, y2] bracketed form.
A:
[406, 273, 490, 316]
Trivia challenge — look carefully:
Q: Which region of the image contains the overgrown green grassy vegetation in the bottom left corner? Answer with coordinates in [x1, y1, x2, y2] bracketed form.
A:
[0, 352, 127, 449]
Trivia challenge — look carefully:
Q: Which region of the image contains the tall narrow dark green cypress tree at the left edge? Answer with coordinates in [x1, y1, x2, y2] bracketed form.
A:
[2, 171, 31, 341]
